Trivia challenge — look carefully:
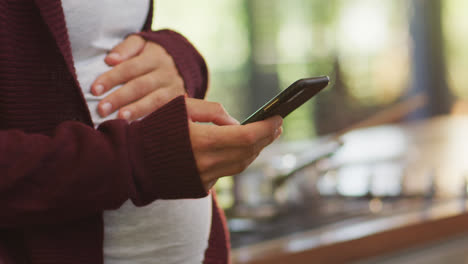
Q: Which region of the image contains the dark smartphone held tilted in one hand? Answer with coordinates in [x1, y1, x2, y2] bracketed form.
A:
[242, 76, 330, 125]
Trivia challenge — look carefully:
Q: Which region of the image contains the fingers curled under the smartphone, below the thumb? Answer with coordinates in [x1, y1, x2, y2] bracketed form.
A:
[189, 116, 282, 189]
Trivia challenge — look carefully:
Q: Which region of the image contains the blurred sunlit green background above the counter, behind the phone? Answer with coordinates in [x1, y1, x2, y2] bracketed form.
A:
[154, 0, 468, 131]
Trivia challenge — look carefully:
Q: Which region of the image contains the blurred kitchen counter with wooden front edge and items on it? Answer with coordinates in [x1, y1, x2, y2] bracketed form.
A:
[231, 117, 468, 264]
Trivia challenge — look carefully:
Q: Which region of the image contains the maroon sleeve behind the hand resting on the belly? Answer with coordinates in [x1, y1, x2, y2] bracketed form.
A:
[138, 29, 208, 99]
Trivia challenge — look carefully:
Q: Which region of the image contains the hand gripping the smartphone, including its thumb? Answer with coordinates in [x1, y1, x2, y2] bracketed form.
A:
[186, 99, 283, 190]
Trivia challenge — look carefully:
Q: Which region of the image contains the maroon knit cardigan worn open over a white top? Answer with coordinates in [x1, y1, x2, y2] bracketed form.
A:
[0, 0, 229, 264]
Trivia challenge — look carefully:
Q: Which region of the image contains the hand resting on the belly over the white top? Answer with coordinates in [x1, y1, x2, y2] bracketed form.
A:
[91, 35, 185, 121]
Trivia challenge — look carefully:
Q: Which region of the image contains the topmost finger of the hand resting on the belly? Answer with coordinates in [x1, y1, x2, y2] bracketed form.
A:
[104, 35, 145, 66]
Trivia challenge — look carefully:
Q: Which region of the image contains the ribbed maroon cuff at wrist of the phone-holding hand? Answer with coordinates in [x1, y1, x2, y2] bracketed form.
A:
[129, 96, 207, 206]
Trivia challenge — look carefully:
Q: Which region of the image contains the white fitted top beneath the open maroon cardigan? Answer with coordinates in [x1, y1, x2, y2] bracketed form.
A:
[62, 0, 212, 264]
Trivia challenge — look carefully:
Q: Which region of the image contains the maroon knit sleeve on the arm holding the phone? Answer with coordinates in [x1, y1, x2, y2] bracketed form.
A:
[0, 96, 206, 228]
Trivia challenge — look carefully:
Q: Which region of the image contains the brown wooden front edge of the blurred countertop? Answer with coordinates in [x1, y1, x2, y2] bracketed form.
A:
[233, 201, 468, 264]
